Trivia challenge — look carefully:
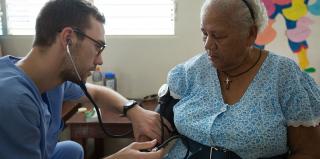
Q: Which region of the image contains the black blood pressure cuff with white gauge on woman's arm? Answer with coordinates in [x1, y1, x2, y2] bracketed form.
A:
[155, 84, 180, 132]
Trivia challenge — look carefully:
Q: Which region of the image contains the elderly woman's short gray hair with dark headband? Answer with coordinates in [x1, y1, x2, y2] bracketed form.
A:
[200, 0, 268, 32]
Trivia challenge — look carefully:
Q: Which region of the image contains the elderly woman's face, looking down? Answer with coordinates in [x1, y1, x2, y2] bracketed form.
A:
[201, 5, 250, 71]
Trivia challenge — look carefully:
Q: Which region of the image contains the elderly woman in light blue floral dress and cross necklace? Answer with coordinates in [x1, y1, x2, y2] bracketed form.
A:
[162, 0, 320, 159]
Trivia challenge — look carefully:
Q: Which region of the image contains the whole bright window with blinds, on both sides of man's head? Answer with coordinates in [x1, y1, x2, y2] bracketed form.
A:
[0, 0, 175, 35]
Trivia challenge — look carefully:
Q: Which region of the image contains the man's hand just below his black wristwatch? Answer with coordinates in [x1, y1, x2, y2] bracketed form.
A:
[128, 106, 172, 143]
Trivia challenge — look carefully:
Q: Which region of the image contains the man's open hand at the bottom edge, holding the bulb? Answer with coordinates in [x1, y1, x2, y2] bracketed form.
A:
[105, 140, 164, 159]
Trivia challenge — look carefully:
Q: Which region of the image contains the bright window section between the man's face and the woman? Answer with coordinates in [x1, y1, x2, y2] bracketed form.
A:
[94, 0, 175, 35]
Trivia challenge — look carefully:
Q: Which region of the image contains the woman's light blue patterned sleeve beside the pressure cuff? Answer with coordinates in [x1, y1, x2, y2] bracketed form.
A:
[167, 64, 187, 99]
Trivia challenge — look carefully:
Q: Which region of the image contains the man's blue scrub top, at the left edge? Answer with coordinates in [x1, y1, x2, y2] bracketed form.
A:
[0, 56, 84, 159]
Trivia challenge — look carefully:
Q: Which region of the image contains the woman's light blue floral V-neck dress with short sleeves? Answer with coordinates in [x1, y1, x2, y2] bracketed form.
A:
[166, 53, 320, 159]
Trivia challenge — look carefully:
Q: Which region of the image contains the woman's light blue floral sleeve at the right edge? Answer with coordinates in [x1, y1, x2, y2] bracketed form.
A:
[279, 61, 320, 127]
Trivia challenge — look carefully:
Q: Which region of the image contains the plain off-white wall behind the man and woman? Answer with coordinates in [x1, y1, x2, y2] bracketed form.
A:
[1, 0, 320, 98]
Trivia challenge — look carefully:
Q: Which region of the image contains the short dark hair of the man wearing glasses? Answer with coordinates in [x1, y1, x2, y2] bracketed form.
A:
[33, 0, 105, 47]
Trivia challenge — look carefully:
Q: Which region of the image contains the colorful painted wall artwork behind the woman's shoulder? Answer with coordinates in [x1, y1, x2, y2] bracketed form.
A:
[255, 0, 320, 73]
